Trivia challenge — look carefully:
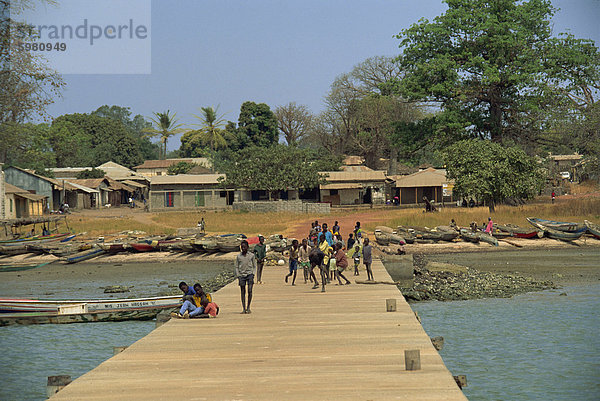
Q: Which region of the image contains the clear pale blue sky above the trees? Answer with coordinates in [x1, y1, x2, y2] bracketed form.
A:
[41, 0, 600, 150]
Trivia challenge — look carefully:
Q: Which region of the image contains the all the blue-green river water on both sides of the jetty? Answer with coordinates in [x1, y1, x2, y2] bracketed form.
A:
[0, 258, 600, 401]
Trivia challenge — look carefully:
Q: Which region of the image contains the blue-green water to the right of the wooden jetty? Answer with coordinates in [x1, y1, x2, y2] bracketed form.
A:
[411, 284, 600, 401]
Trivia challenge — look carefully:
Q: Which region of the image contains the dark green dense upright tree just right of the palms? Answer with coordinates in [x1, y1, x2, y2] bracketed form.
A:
[238, 102, 279, 147]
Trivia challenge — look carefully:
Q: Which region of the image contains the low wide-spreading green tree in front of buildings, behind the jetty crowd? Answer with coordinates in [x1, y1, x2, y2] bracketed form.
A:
[220, 145, 339, 199]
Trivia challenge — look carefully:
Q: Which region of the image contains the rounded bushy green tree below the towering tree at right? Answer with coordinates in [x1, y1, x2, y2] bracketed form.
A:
[444, 139, 544, 212]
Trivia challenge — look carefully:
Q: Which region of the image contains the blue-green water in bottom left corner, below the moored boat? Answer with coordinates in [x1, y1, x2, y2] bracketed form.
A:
[0, 321, 155, 401]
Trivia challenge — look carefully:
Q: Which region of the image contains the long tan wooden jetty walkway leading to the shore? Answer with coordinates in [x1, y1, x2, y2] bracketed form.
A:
[51, 261, 466, 401]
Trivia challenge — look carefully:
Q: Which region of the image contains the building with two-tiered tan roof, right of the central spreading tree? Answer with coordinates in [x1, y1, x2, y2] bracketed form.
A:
[319, 165, 386, 205]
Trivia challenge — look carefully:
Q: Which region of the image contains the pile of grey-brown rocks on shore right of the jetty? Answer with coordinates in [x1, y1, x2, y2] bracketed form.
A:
[400, 255, 557, 302]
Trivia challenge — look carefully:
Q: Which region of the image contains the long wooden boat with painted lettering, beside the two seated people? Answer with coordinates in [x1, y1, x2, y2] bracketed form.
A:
[0, 295, 181, 326]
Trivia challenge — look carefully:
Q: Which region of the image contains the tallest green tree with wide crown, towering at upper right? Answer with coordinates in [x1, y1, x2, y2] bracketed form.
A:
[397, 0, 596, 145]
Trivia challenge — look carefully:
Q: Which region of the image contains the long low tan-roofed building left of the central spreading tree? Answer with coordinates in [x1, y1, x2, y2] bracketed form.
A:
[149, 174, 240, 210]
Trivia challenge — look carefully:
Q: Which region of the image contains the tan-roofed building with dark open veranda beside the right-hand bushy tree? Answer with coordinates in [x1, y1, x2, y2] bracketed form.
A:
[389, 167, 455, 205]
